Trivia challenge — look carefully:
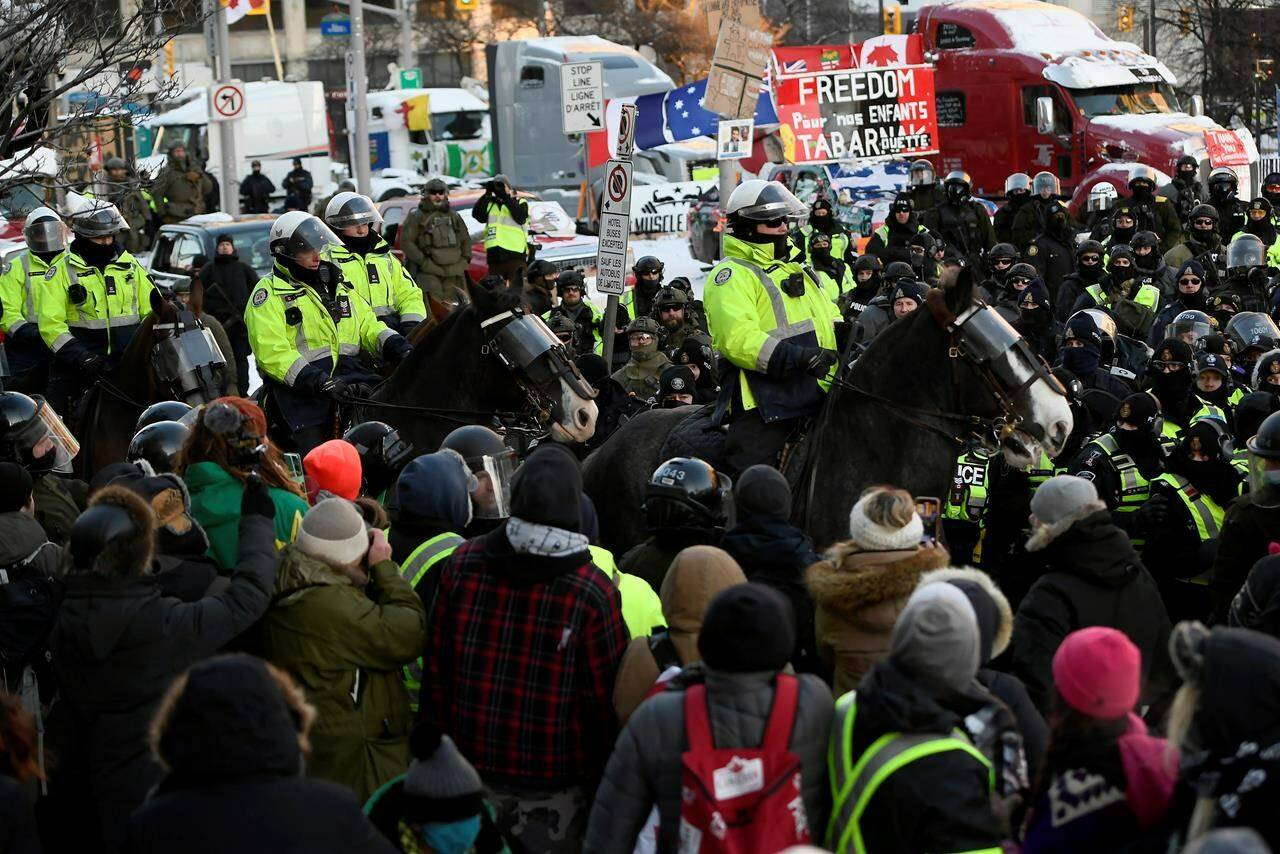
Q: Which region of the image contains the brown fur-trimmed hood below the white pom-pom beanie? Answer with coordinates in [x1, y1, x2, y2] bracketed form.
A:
[805, 540, 951, 620]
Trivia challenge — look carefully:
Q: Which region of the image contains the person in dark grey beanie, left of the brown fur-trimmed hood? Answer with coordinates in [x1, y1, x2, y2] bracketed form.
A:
[721, 465, 829, 675]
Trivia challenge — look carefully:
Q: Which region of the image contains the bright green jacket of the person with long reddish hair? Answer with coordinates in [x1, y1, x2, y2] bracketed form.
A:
[182, 463, 307, 572]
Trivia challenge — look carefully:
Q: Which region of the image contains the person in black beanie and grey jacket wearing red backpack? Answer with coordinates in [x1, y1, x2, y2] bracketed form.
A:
[584, 584, 832, 851]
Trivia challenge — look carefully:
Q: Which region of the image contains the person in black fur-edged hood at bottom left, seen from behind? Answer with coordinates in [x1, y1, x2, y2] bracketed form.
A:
[128, 656, 394, 854]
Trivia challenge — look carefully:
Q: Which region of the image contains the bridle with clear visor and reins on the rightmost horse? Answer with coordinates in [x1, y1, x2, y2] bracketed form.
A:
[836, 289, 1066, 452]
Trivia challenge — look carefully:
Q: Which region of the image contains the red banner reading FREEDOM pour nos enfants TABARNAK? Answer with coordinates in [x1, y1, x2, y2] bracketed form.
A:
[773, 65, 938, 163]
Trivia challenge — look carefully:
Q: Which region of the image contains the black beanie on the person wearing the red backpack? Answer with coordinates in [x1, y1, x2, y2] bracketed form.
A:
[698, 583, 796, 673]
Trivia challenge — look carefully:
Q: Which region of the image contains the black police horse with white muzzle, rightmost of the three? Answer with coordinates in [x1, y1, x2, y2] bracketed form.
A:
[582, 270, 1071, 553]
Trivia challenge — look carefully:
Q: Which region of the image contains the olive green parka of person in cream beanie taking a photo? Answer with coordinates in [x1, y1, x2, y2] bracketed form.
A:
[262, 547, 426, 803]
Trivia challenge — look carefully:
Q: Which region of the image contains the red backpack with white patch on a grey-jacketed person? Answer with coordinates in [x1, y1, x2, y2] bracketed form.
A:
[680, 673, 809, 854]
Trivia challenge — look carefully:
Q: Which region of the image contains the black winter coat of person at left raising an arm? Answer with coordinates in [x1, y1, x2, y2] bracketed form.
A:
[50, 516, 276, 851]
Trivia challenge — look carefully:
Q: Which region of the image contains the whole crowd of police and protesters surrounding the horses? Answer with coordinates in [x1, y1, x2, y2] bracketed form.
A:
[0, 153, 1280, 854]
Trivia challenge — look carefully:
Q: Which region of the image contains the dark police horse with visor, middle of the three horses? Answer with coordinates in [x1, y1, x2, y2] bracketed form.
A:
[360, 277, 596, 453]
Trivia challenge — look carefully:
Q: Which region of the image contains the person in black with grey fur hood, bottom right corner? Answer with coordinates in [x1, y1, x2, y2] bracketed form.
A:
[1169, 622, 1280, 850]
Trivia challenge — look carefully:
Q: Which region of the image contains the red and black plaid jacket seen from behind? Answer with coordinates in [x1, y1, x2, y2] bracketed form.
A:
[421, 529, 628, 790]
